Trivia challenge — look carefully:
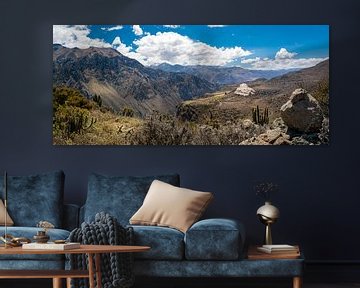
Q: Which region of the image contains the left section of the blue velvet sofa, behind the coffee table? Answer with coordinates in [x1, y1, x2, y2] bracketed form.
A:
[0, 171, 79, 269]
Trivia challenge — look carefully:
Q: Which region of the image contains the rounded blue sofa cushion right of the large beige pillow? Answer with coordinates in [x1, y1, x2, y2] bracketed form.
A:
[185, 219, 245, 260]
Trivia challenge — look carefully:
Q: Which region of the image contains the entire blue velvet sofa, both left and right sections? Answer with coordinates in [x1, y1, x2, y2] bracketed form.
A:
[0, 171, 303, 287]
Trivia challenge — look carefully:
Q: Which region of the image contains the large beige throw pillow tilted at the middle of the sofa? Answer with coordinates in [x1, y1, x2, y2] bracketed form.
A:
[130, 180, 213, 233]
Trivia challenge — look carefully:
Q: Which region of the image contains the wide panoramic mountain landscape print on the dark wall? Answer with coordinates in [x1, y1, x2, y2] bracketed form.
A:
[52, 25, 329, 145]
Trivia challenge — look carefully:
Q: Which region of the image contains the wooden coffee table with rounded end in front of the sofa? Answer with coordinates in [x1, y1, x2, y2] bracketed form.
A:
[0, 245, 150, 288]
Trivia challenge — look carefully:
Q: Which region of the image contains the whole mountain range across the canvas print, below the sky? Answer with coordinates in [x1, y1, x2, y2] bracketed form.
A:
[53, 44, 329, 116]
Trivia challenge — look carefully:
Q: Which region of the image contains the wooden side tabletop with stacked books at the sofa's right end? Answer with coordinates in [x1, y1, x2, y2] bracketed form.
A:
[248, 244, 300, 259]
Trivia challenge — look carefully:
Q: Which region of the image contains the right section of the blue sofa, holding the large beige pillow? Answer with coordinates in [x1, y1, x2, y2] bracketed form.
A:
[80, 174, 303, 287]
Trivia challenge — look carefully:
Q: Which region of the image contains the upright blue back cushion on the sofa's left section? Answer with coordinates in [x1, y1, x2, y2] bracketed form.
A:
[0, 171, 64, 228]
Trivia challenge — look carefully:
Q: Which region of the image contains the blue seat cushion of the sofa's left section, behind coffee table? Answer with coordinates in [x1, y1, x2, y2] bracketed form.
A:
[0, 227, 70, 260]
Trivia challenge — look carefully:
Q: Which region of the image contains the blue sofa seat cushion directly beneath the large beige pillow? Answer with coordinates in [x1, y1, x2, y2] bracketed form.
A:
[132, 226, 184, 260]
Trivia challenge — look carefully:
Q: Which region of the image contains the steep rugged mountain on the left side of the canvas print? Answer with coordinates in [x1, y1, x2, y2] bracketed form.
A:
[53, 44, 218, 116]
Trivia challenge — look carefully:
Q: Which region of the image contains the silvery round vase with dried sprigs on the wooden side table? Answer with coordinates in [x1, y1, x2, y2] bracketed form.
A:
[254, 182, 280, 245]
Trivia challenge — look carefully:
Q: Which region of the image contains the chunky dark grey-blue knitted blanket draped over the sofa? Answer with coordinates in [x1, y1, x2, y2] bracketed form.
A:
[68, 212, 134, 288]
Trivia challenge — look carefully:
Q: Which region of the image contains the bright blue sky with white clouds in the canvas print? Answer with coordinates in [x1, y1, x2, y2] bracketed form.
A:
[53, 25, 329, 70]
